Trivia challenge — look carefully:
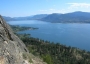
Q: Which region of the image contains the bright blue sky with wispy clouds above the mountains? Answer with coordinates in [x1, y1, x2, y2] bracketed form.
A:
[0, 0, 90, 17]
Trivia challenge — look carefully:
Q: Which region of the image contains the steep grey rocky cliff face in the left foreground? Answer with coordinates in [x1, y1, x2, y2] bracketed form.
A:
[0, 16, 44, 64]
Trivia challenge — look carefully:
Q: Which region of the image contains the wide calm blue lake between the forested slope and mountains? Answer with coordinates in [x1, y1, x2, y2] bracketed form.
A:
[8, 20, 90, 51]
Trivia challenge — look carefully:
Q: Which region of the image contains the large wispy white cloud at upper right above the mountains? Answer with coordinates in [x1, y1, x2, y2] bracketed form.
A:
[67, 3, 90, 9]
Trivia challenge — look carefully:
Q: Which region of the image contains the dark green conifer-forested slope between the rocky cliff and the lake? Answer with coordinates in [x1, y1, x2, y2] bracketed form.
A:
[11, 25, 90, 64]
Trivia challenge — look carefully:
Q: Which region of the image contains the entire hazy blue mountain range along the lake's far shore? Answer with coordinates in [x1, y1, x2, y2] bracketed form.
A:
[4, 11, 90, 23]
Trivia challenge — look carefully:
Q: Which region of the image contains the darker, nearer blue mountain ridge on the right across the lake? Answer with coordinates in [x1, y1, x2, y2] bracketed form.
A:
[41, 11, 90, 23]
